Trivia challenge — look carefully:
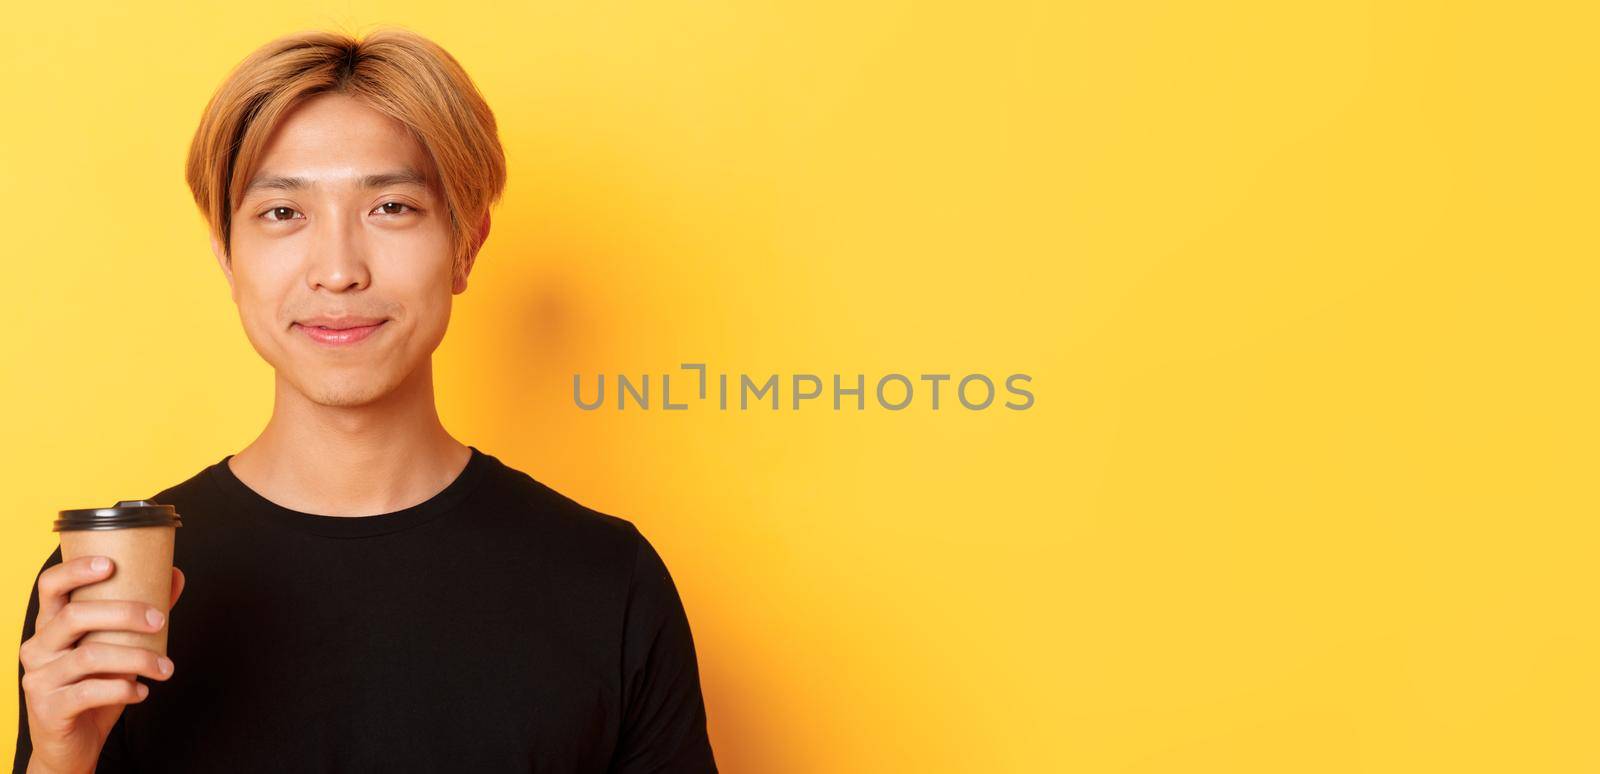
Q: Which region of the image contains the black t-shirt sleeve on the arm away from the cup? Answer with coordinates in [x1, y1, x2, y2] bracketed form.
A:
[611, 528, 717, 774]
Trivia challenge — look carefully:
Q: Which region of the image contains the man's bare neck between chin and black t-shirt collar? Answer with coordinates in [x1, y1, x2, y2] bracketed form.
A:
[229, 361, 472, 517]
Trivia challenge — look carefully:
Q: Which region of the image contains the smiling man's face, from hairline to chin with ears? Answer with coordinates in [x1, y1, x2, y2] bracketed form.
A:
[213, 93, 466, 406]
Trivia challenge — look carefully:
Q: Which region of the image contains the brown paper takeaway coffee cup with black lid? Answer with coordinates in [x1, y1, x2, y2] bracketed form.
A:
[54, 501, 182, 656]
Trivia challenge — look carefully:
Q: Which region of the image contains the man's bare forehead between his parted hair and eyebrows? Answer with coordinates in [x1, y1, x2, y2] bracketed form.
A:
[251, 93, 434, 184]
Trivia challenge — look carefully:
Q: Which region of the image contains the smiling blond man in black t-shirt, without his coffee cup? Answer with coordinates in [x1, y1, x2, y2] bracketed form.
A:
[16, 30, 717, 772]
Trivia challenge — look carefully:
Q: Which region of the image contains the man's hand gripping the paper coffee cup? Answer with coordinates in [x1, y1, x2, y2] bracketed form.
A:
[19, 557, 184, 774]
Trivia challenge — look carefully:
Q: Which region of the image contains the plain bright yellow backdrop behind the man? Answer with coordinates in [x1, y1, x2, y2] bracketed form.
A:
[0, 0, 1600, 774]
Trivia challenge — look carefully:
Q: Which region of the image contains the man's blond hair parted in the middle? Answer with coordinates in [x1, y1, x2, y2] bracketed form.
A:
[186, 27, 506, 270]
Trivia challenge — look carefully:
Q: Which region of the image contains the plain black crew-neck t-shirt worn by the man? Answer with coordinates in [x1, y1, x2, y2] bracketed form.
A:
[16, 448, 717, 772]
